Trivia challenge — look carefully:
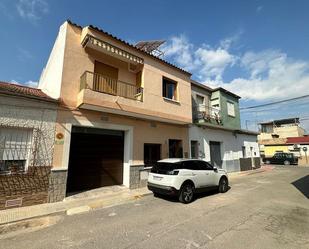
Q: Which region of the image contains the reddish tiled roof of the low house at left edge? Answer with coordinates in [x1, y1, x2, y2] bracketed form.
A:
[0, 81, 58, 102]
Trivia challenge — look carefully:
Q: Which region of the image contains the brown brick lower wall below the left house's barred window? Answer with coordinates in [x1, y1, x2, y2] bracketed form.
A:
[0, 166, 51, 210]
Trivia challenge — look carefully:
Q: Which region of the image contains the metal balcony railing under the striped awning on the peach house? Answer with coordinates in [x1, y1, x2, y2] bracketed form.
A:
[80, 71, 143, 101]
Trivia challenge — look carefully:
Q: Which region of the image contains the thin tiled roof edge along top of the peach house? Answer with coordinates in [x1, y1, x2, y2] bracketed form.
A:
[67, 20, 192, 76]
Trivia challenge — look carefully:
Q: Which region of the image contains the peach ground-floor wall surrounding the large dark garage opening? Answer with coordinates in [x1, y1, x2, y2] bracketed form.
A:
[53, 110, 189, 168]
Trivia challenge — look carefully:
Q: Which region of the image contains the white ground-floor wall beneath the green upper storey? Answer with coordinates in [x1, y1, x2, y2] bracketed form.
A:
[189, 125, 260, 171]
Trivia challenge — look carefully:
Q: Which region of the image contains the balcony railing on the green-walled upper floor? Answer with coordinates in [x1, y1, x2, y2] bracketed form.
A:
[193, 105, 223, 125]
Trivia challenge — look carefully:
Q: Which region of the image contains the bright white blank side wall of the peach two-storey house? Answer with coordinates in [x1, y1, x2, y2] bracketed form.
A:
[38, 22, 68, 99]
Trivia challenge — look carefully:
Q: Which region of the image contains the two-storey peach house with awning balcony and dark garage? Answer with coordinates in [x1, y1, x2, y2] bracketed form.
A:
[39, 21, 192, 201]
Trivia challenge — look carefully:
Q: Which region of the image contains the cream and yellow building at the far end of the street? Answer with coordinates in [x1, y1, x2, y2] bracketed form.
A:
[258, 118, 305, 157]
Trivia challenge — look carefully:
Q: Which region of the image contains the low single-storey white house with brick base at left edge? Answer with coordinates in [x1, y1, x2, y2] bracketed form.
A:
[0, 82, 58, 210]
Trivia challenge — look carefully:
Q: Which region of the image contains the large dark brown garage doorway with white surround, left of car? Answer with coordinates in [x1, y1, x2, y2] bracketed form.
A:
[67, 127, 124, 193]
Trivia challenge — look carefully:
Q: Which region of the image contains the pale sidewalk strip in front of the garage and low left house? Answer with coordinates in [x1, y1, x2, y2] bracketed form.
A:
[0, 186, 151, 226]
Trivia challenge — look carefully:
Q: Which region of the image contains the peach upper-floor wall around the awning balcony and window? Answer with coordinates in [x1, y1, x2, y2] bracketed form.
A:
[61, 22, 192, 123]
